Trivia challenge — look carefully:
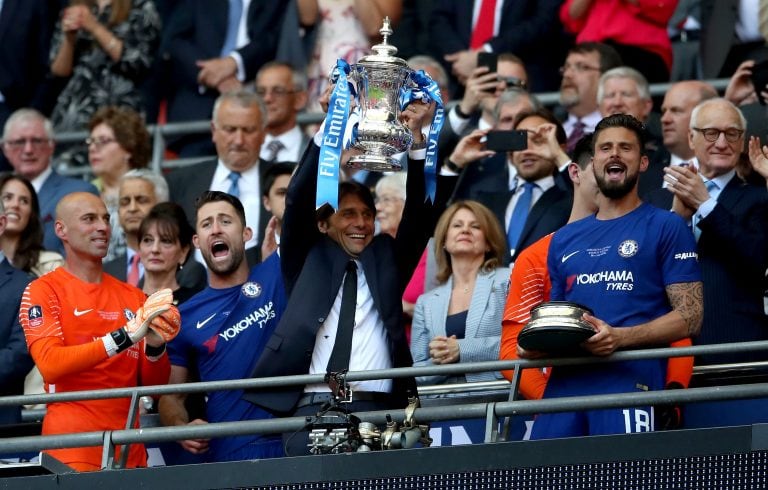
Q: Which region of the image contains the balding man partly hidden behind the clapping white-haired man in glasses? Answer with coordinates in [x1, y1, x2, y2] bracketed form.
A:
[640, 80, 717, 204]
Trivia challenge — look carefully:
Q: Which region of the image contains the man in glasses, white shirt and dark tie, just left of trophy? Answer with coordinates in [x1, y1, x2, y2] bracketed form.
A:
[256, 61, 309, 163]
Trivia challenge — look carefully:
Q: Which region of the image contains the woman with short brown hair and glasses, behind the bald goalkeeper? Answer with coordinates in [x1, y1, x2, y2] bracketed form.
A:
[85, 106, 152, 262]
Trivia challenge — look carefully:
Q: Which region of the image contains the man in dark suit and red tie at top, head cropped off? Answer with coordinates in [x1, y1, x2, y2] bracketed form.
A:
[429, 0, 563, 92]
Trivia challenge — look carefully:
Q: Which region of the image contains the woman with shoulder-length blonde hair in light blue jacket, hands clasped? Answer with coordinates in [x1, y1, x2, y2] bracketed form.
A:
[411, 201, 509, 385]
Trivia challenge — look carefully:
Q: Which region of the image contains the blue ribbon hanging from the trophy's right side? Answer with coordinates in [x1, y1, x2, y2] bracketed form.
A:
[400, 70, 445, 202]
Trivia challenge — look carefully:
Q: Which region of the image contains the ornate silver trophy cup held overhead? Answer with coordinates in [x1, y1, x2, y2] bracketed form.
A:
[347, 17, 413, 172]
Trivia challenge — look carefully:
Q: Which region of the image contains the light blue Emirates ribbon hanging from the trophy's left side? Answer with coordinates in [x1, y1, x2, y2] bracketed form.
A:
[315, 59, 355, 210]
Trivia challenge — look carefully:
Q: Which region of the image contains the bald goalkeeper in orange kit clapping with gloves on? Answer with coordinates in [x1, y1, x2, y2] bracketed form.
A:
[19, 192, 180, 471]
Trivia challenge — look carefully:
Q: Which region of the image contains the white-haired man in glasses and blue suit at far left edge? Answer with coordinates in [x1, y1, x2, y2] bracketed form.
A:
[3, 109, 99, 254]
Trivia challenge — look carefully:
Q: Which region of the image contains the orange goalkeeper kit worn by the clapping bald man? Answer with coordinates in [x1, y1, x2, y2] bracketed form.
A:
[19, 267, 170, 470]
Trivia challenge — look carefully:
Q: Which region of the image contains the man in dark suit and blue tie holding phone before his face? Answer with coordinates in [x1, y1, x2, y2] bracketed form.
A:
[451, 109, 573, 261]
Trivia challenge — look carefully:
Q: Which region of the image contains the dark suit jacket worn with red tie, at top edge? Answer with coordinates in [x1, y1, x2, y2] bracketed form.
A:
[429, 0, 565, 92]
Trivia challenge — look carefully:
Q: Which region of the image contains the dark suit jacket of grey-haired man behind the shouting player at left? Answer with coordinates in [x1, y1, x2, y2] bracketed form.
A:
[167, 159, 272, 263]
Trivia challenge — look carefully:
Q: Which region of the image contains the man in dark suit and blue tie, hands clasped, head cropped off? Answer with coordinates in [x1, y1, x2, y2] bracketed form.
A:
[164, 0, 283, 155]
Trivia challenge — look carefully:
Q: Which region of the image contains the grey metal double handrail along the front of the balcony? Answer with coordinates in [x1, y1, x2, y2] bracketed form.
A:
[0, 341, 768, 466]
